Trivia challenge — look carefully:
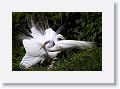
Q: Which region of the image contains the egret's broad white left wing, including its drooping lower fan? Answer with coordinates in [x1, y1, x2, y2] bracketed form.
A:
[20, 38, 47, 68]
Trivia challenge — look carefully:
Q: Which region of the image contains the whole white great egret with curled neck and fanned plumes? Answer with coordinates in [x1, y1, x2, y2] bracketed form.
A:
[20, 20, 93, 68]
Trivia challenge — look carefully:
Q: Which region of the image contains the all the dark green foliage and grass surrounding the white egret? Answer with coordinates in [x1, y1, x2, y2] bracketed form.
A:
[12, 12, 102, 71]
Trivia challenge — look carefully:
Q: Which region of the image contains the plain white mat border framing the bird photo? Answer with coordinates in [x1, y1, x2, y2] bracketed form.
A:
[0, 0, 114, 83]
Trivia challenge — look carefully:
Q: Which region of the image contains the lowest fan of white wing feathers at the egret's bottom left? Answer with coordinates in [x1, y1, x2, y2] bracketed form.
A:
[20, 53, 46, 68]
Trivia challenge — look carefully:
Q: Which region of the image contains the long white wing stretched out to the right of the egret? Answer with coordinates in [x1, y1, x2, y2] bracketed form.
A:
[47, 40, 94, 52]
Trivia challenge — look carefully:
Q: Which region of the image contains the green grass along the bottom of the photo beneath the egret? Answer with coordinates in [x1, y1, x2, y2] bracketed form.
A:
[12, 47, 102, 71]
